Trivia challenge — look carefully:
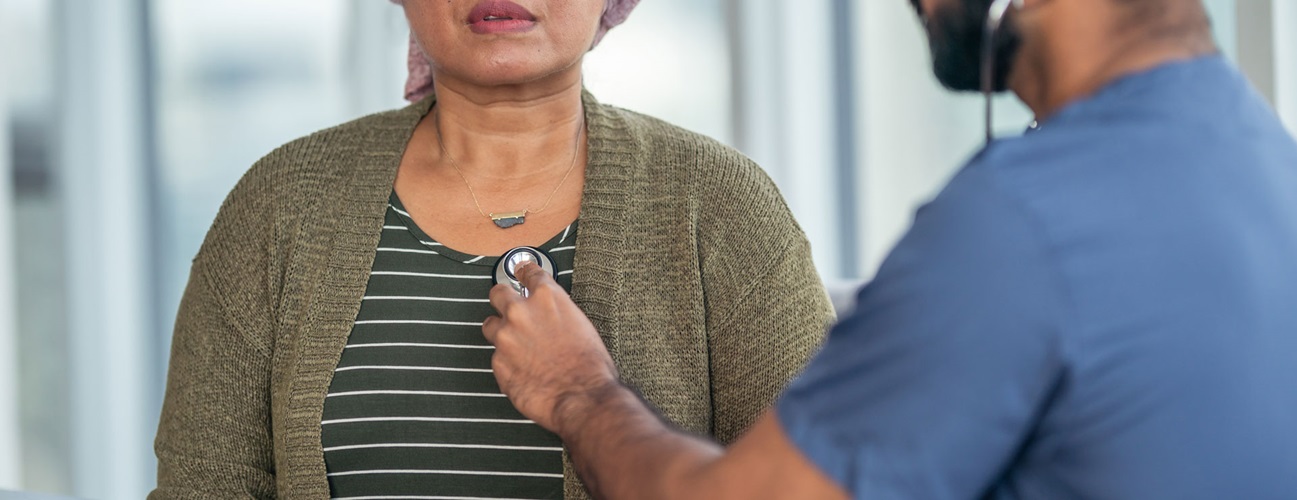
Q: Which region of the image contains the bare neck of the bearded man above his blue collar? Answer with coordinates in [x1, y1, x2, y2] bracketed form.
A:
[1009, 0, 1218, 120]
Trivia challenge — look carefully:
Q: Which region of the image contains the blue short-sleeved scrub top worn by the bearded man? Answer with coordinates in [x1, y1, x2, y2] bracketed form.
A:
[777, 57, 1297, 499]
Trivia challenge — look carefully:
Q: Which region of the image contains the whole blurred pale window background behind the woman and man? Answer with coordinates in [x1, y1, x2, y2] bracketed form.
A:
[0, 0, 1297, 499]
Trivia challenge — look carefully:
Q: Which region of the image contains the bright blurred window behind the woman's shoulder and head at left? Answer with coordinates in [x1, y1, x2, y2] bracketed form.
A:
[153, 0, 406, 354]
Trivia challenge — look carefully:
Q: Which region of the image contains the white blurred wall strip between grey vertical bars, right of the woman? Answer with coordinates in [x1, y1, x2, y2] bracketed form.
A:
[730, 0, 843, 280]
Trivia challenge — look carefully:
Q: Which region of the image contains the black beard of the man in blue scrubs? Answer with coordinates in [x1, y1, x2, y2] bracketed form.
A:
[913, 0, 1022, 92]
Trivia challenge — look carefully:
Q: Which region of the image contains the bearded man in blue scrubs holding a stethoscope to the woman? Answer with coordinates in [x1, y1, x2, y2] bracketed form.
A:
[484, 0, 1297, 499]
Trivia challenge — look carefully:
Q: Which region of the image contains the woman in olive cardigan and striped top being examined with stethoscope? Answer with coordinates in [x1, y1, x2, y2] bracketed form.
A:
[152, 0, 831, 499]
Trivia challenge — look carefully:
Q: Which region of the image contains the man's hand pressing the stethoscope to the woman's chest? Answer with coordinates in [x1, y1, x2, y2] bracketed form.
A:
[482, 263, 621, 435]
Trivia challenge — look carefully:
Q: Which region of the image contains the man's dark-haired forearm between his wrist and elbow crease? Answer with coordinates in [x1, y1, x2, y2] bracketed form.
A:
[556, 383, 724, 500]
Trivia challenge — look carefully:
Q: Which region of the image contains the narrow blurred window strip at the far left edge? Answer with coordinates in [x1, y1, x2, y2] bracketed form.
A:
[0, 0, 73, 494]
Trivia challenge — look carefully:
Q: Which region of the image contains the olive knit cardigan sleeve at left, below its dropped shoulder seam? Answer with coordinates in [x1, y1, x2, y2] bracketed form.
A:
[149, 264, 275, 500]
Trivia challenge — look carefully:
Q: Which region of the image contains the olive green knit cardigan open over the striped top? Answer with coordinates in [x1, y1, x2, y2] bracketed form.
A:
[149, 93, 833, 499]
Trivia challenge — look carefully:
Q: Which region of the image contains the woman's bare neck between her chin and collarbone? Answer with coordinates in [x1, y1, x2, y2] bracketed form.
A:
[424, 73, 585, 184]
